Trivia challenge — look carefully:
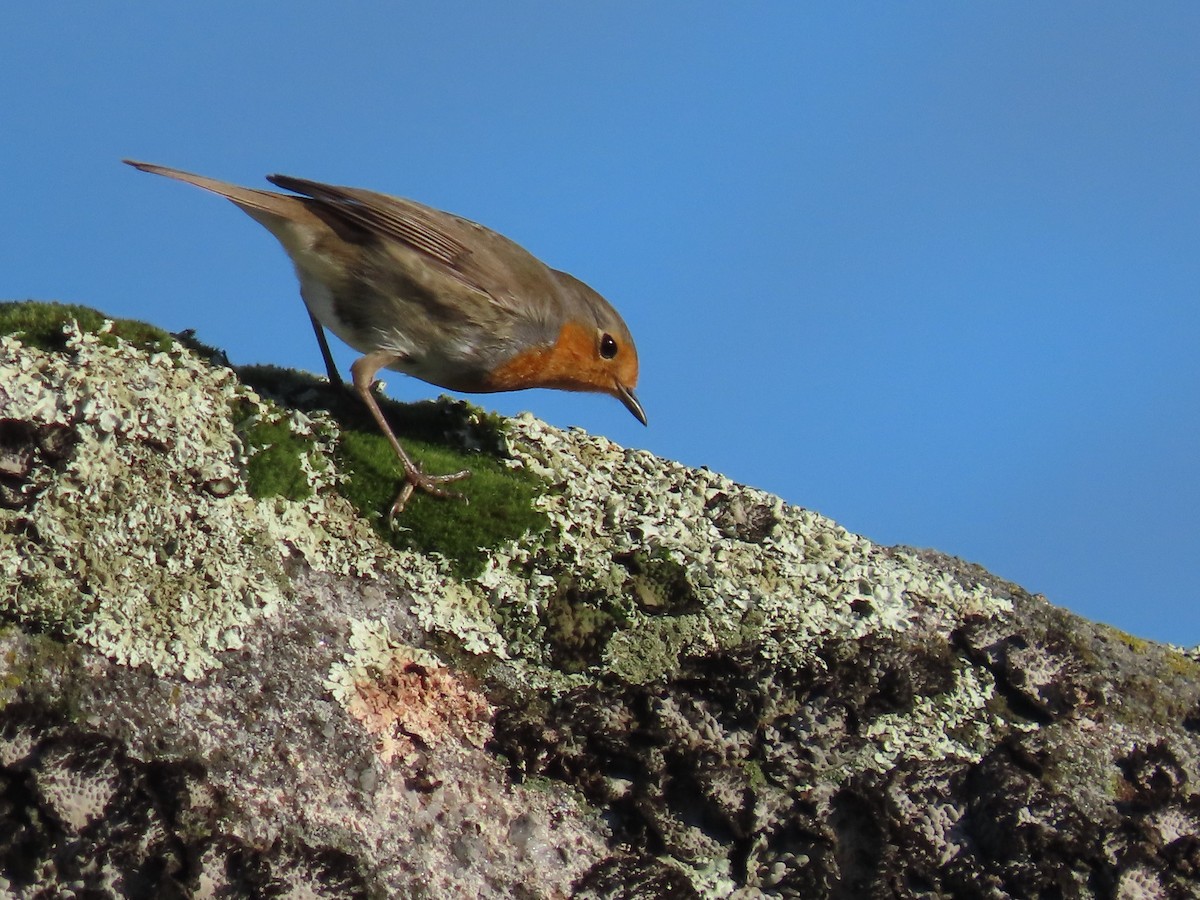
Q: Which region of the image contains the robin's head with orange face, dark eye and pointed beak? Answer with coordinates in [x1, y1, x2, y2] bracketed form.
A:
[482, 271, 646, 425]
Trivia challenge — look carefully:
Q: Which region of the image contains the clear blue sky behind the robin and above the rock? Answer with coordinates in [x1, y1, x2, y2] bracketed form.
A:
[0, 1, 1200, 644]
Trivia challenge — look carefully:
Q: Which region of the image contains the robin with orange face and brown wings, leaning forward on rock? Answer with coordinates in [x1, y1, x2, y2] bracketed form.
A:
[122, 160, 647, 522]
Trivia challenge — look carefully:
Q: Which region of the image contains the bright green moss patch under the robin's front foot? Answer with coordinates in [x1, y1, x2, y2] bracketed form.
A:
[337, 431, 547, 577]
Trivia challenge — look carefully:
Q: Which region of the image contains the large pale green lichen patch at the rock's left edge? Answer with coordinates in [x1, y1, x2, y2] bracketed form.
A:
[0, 323, 378, 678]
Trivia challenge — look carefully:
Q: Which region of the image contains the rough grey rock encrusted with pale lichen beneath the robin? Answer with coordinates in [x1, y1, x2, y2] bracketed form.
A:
[0, 307, 1200, 899]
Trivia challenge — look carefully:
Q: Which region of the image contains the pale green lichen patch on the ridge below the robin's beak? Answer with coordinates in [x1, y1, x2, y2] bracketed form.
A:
[458, 415, 1010, 685]
